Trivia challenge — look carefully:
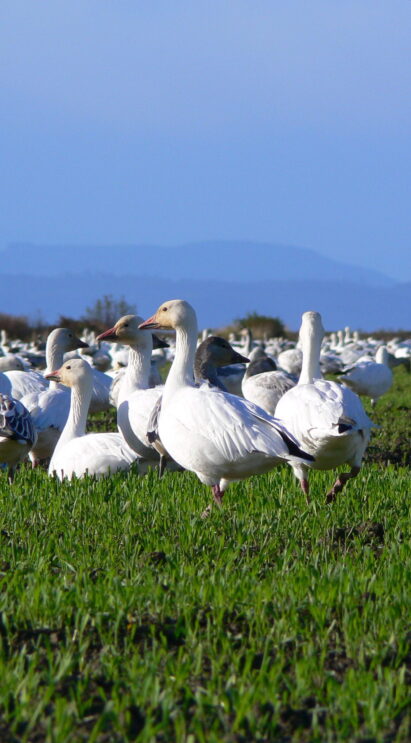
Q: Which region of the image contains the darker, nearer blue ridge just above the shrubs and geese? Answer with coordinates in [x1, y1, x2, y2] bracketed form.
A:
[0, 273, 411, 335]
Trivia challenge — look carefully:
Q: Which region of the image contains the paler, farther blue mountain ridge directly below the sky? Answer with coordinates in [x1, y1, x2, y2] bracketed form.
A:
[0, 240, 396, 287]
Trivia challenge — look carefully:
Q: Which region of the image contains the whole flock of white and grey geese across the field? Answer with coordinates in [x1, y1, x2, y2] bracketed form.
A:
[0, 299, 411, 515]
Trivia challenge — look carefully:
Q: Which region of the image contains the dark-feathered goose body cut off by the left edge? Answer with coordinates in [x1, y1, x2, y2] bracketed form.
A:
[0, 394, 37, 480]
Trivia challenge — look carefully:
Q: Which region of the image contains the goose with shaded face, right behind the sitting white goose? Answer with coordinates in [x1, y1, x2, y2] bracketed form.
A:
[22, 328, 87, 466]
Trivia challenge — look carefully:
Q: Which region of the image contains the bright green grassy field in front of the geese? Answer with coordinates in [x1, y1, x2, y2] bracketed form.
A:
[0, 370, 411, 743]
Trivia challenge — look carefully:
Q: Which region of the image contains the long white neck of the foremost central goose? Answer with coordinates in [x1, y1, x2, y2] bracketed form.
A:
[162, 318, 197, 409]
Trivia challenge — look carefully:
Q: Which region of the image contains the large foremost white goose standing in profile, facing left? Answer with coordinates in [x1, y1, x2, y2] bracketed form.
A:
[140, 299, 312, 505]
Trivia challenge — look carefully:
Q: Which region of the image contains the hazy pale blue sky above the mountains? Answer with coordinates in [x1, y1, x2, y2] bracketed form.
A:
[0, 0, 411, 280]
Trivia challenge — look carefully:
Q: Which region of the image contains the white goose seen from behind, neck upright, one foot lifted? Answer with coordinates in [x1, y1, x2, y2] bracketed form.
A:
[275, 312, 373, 501]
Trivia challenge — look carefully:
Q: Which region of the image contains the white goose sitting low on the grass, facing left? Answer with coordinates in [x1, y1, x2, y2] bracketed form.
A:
[47, 359, 135, 480]
